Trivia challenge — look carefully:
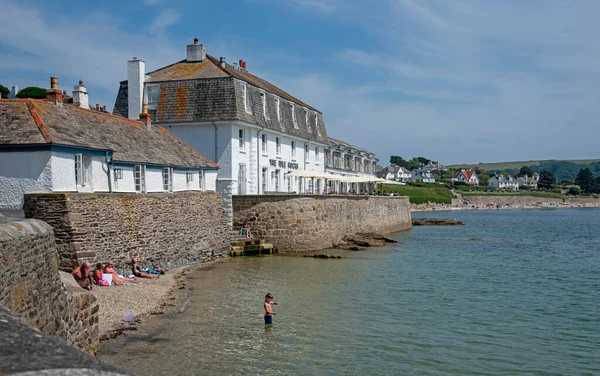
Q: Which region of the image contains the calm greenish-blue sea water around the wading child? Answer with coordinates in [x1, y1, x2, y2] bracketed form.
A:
[100, 209, 600, 375]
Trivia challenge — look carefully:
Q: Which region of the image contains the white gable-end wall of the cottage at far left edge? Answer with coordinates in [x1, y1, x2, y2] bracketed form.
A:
[0, 151, 52, 209]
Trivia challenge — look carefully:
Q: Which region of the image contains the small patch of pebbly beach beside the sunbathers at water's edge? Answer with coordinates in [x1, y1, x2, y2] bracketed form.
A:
[91, 258, 226, 340]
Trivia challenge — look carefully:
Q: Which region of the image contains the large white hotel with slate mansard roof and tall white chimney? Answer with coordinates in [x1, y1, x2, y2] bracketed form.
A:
[113, 39, 329, 204]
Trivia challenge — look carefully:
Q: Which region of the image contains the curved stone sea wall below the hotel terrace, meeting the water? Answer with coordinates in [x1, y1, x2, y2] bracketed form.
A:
[233, 195, 412, 252]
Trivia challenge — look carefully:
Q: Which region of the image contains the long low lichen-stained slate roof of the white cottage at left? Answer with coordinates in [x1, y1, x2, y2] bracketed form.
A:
[0, 99, 218, 168]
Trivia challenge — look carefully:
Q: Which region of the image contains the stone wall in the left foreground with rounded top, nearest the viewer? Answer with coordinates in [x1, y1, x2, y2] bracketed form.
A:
[0, 217, 99, 354]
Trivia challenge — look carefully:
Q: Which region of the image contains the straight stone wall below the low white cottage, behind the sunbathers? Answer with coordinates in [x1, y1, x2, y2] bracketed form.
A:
[24, 192, 231, 269]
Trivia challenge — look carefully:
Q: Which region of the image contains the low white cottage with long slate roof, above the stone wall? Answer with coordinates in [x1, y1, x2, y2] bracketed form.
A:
[0, 78, 218, 214]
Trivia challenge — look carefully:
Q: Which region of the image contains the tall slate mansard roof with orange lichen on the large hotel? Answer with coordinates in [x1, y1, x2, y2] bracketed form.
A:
[113, 55, 327, 144]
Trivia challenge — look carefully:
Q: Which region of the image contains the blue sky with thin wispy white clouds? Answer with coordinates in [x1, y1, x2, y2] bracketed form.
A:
[0, 0, 600, 165]
